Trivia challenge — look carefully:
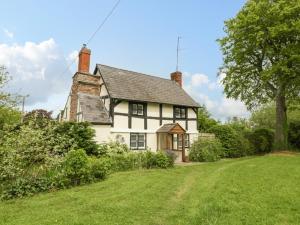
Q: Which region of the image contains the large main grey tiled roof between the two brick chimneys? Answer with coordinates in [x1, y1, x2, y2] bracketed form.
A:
[97, 64, 199, 107]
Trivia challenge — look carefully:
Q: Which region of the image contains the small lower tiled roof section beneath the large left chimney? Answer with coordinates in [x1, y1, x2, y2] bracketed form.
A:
[78, 93, 111, 124]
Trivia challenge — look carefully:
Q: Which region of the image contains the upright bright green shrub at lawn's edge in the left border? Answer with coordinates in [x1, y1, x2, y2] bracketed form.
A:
[64, 149, 90, 185]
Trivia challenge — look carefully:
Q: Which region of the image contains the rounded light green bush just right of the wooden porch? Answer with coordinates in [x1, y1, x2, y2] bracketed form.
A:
[189, 139, 224, 162]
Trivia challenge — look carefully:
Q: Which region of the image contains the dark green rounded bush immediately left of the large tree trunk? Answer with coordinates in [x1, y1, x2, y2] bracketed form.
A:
[248, 128, 274, 154]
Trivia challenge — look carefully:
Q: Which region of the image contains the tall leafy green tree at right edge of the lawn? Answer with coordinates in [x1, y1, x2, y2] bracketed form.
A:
[219, 0, 300, 150]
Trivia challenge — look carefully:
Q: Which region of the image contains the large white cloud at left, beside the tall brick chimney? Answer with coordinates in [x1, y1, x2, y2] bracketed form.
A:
[0, 38, 72, 113]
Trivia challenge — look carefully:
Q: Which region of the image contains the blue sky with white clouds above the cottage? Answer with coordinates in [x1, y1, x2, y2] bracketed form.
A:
[0, 0, 247, 120]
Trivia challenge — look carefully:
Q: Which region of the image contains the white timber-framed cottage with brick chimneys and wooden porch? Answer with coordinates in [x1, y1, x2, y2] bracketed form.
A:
[60, 45, 199, 161]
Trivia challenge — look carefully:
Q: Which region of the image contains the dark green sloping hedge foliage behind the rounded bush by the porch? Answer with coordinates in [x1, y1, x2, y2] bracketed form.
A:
[208, 124, 252, 158]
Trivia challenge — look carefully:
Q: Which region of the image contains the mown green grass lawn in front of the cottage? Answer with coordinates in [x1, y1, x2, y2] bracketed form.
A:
[0, 155, 300, 225]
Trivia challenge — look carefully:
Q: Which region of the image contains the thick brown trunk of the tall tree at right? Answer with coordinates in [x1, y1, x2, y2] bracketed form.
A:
[274, 89, 288, 151]
